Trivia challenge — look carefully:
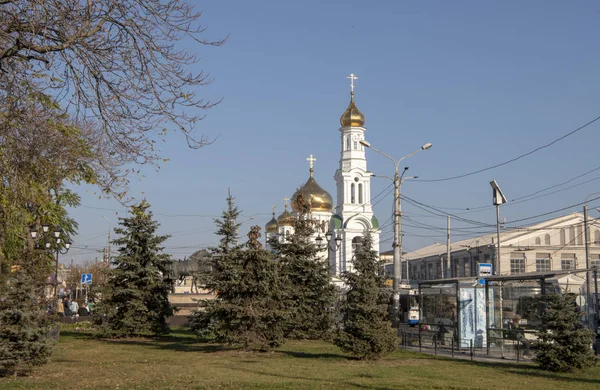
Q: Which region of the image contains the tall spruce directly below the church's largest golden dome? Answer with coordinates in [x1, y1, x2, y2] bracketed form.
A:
[269, 195, 336, 339]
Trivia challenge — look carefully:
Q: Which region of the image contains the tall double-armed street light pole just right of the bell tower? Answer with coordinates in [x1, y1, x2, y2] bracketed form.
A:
[359, 141, 433, 326]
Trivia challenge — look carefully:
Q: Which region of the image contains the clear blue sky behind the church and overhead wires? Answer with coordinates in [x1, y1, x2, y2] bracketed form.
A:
[61, 0, 600, 262]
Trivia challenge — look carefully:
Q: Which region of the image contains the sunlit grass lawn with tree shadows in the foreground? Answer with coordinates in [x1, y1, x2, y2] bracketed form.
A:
[0, 330, 600, 390]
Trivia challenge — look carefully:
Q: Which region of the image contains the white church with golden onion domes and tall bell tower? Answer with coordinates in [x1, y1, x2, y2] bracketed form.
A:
[265, 74, 381, 277]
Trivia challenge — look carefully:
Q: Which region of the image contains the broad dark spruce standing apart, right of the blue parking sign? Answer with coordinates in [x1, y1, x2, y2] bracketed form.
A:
[96, 201, 173, 336]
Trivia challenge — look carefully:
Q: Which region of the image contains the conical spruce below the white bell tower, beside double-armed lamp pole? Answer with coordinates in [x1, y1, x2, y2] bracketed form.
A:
[334, 235, 397, 359]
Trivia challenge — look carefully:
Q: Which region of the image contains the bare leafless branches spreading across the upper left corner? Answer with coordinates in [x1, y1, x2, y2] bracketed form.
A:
[0, 0, 225, 173]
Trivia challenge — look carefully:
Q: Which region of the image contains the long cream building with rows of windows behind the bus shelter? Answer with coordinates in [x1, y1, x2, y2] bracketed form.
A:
[403, 213, 600, 281]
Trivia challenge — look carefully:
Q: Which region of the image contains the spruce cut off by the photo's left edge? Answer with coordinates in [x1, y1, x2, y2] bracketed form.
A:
[0, 270, 55, 375]
